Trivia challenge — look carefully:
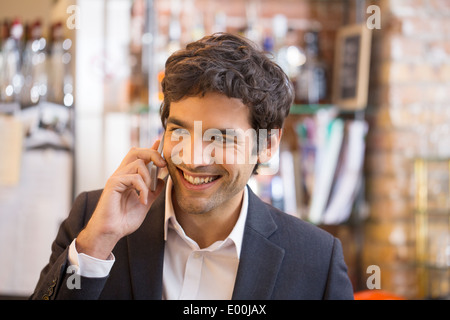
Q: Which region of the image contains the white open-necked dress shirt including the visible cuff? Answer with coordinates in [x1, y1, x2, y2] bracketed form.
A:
[69, 176, 248, 300]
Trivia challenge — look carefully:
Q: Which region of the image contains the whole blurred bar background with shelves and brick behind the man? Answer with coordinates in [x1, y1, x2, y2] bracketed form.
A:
[0, 0, 450, 299]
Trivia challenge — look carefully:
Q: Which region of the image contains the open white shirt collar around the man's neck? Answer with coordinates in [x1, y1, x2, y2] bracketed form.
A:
[164, 175, 248, 259]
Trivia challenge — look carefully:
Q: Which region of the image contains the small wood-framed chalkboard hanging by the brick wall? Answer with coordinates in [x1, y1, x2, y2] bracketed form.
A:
[333, 25, 372, 110]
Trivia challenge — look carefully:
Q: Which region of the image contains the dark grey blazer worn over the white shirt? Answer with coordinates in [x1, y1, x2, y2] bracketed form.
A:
[30, 188, 353, 300]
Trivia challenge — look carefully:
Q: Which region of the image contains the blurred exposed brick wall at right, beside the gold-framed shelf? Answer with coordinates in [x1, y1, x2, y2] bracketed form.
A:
[362, 0, 450, 298]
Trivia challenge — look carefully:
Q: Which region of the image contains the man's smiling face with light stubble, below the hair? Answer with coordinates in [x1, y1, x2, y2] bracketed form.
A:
[164, 93, 256, 218]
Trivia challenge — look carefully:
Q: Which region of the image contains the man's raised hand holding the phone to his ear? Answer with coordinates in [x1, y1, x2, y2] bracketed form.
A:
[76, 141, 166, 259]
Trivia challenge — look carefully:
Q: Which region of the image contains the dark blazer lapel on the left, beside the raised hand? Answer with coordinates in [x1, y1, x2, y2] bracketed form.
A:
[127, 189, 165, 300]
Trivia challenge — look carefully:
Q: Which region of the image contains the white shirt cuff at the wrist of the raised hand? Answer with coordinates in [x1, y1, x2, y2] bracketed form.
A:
[69, 238, 116, 278]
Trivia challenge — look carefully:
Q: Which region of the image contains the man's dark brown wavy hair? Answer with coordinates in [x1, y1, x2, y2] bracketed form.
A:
[160, 33, 294, 170]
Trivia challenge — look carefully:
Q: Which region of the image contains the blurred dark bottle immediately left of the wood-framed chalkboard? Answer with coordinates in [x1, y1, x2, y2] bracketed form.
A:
[295, 31, 328, 105]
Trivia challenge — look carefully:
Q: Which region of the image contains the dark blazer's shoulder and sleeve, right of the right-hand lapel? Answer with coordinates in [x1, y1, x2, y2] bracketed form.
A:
[264, 201, 353, 300]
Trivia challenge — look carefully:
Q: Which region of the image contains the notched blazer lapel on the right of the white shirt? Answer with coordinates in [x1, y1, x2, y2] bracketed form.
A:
[232, 188, 284, 300]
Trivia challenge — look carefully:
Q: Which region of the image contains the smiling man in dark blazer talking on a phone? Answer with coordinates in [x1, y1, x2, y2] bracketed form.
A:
[32, 34, 353, 299]
